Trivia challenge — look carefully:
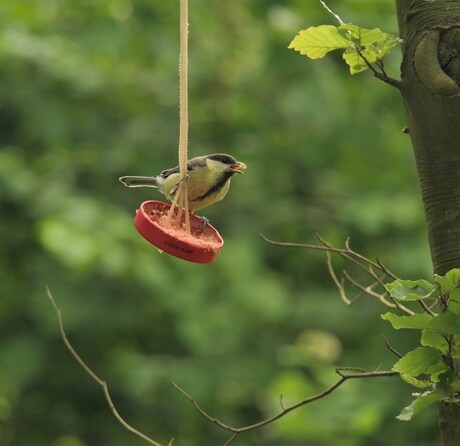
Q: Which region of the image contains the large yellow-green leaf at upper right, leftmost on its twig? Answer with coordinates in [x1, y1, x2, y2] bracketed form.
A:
[288, 25, 351, 59]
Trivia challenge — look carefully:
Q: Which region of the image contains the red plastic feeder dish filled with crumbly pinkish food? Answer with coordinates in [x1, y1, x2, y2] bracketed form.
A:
[134, 200, 224, 263]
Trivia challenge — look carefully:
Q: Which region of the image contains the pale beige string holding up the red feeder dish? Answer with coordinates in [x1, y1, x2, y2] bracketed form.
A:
[167, 0, 190, 232]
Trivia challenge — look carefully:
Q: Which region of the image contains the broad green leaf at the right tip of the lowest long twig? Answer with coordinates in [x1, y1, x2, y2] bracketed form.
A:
[393, 347, 447, 381]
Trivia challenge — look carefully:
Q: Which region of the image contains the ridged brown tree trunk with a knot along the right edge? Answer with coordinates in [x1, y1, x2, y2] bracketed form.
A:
[396, 0, 460, 446]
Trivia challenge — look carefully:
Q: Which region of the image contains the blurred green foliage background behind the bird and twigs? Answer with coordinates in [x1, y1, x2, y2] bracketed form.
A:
[0, 0, 438, 446]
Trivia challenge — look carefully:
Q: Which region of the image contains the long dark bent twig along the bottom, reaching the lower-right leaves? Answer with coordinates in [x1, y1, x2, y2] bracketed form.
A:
[171, 367, 399, 438]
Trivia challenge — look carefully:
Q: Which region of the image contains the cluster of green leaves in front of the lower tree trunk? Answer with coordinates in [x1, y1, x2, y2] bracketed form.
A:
[382, 269, 460, 420]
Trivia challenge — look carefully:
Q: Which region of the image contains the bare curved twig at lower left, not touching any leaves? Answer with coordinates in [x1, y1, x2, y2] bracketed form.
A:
[46, 286, 165, 446]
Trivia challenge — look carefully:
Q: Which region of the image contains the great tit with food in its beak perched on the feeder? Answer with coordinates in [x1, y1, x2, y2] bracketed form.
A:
[119, 153, 246, 211]
